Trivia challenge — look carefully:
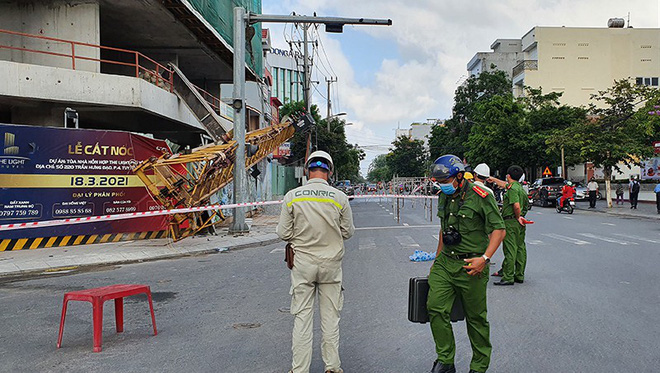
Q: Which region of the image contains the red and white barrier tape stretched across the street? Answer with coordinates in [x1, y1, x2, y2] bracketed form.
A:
[0, 194, 438, 231]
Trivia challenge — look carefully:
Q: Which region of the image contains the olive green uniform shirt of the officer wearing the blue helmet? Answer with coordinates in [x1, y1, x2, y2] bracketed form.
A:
[438, 182, 504, 255]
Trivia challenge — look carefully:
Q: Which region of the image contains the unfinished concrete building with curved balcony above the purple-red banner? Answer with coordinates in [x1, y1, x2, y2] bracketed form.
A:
[0, 0, 262, 147]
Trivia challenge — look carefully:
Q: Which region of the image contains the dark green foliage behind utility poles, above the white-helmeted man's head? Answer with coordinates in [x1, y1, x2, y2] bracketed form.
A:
[280, 101, 365, 182]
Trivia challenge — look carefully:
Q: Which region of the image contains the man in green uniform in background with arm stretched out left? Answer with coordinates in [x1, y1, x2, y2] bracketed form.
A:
[490, 166, 529, 286]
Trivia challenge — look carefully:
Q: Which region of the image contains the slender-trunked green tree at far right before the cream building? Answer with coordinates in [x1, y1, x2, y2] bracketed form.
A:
[548, 79, 660, 207]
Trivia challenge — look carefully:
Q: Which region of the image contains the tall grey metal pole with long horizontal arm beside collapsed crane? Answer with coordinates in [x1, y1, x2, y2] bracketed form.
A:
[229, 7, 392, 233]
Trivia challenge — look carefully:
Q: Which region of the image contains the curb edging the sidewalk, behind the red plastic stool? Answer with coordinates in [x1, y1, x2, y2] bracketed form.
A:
[0, 234, 282, 283]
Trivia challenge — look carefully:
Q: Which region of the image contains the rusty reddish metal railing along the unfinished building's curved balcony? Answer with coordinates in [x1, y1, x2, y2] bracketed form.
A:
[0, 29, 174, 92]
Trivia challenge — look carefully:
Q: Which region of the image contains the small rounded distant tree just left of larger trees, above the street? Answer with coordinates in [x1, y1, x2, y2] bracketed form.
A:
[386, 136, 426, 177]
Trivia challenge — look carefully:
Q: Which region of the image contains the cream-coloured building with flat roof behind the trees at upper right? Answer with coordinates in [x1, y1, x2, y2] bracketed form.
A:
[513, 27, 660, 106]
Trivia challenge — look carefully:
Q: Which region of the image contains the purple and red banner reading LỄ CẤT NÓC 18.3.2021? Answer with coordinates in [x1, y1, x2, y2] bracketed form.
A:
[0, 124, 171, 239]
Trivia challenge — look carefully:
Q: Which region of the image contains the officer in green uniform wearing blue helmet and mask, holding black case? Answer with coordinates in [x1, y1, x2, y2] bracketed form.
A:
[427, 155, 505, 373]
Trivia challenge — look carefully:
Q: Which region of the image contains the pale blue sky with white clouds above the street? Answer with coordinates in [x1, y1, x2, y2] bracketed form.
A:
[262, 0, 660, 177]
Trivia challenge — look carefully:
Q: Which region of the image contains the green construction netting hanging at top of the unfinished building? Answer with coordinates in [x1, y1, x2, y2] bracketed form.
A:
[189, 0, 263, 76]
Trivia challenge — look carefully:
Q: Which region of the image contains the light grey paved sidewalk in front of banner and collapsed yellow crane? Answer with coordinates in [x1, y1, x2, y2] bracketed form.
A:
[0, 215, 280, 280]
